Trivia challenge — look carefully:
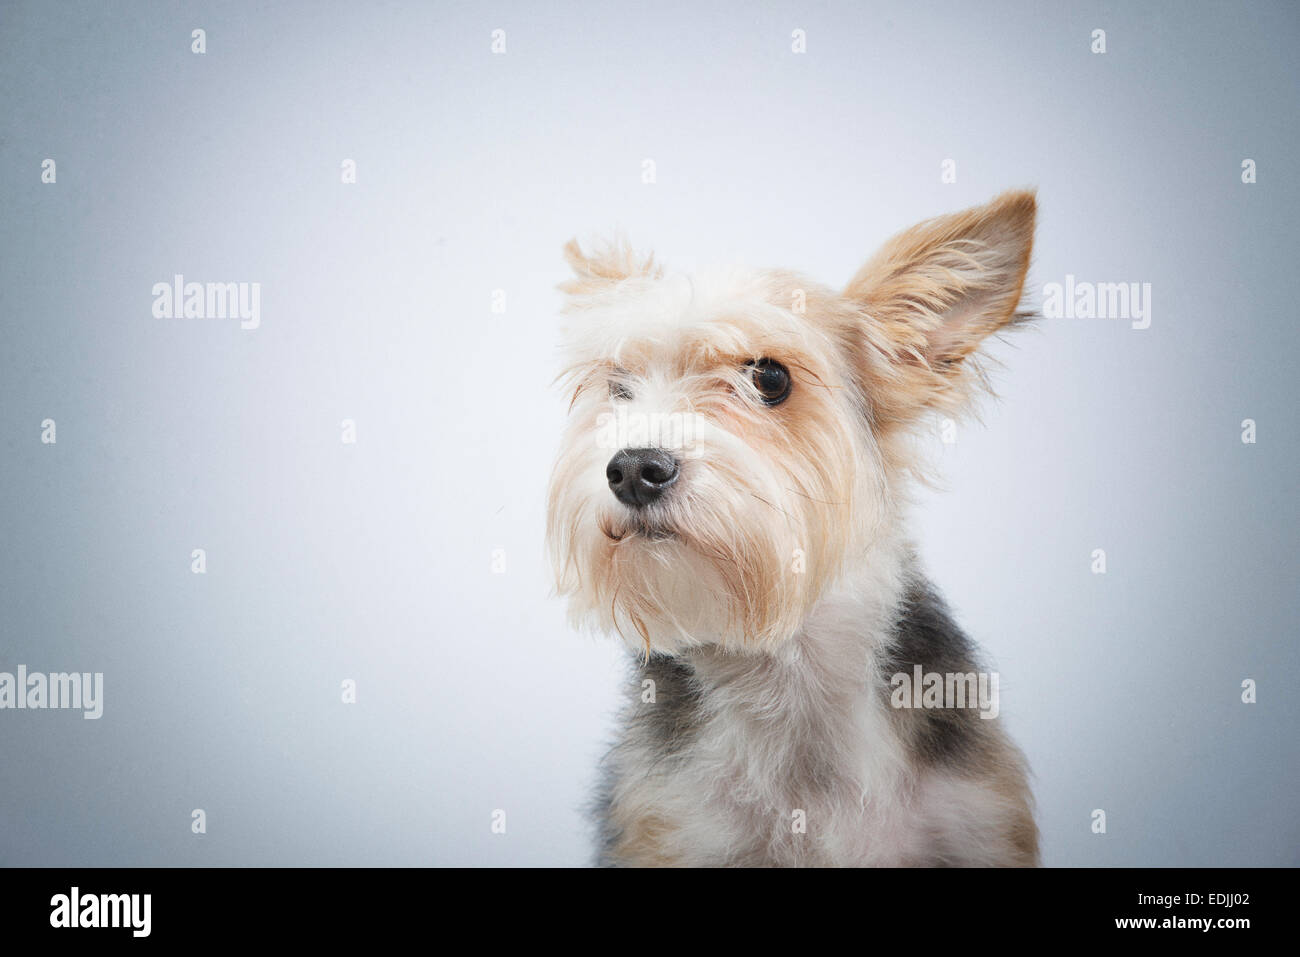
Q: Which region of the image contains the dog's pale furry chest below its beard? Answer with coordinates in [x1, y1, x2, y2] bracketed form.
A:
[608, 613, 924, 865]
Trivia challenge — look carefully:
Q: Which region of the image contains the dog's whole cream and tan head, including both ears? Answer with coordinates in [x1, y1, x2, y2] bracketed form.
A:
[547, 192, 1034, 653]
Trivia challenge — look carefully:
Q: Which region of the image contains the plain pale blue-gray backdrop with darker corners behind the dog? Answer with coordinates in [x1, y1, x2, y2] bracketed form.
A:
[0, 0, 1300, 865]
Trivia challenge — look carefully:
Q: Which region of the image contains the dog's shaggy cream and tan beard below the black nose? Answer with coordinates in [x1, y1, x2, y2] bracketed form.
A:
[549, 421, 854, 654]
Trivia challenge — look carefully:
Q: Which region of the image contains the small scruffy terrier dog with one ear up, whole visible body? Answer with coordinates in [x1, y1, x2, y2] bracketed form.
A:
[547, 191, 1037, 866]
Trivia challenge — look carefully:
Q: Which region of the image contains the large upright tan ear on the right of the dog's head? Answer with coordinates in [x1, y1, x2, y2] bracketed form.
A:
[844, 191, 1035, 425]
